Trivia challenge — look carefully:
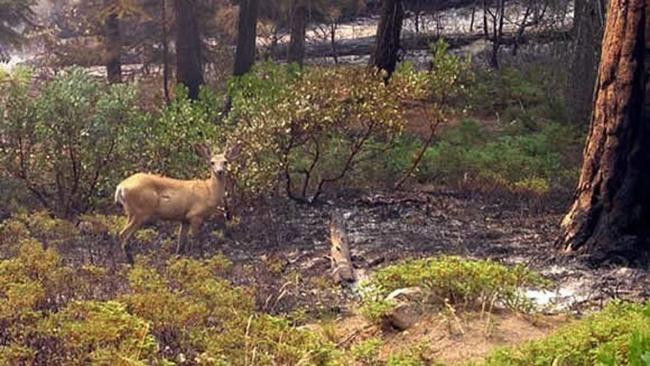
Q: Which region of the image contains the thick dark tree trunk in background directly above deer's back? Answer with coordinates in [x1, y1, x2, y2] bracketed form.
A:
[174, 0, 203, 99]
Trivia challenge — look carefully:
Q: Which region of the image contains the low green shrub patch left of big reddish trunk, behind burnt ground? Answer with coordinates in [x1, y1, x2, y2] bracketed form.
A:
[388, 120, 578, 194]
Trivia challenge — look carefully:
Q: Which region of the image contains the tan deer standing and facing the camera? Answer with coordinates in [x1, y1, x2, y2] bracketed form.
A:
[115, 143, 241, 264]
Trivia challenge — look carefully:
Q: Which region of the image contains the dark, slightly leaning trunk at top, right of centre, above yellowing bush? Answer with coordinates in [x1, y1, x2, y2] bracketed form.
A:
[370, 0, 404, 80]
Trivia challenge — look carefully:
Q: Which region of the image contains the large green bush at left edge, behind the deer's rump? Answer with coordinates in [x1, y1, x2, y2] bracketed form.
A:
[0, 69, 141, 215]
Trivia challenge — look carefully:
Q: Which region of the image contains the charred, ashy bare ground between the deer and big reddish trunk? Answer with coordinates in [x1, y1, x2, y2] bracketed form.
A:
[64, 187, 650, 364]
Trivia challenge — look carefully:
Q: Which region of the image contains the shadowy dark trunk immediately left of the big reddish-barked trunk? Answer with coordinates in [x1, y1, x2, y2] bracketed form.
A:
[567, 0, 605, 123]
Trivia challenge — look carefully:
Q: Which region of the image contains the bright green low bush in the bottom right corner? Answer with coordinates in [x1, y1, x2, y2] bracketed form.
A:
[482, 302, 650, 366]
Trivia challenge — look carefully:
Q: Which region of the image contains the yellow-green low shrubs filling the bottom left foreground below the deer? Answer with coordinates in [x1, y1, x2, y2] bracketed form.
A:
[0, 233, 342, 365]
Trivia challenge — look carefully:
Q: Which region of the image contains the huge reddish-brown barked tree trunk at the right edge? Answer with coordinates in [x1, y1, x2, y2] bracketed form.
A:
[559, 0, 650, 261]
